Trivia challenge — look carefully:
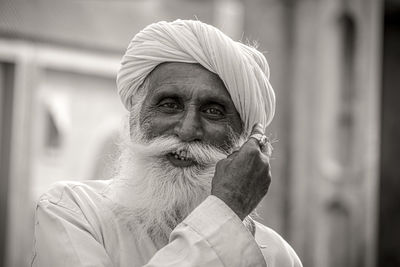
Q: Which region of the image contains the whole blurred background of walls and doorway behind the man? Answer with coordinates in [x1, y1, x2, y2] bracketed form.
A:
[0, 0, 400, 267]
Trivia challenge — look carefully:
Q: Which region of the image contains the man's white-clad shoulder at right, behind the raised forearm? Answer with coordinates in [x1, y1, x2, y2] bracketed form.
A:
[254, 221, 302, 267]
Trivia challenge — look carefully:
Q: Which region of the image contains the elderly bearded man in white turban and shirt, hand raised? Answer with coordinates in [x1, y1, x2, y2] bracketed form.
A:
[33, 20, 301, 267]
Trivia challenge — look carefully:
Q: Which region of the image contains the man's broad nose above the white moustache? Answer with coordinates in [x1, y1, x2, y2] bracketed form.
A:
[175, 108, 203, 142]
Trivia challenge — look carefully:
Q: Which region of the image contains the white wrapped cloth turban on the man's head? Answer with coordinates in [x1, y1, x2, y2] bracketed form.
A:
[117, 20, 275, 133]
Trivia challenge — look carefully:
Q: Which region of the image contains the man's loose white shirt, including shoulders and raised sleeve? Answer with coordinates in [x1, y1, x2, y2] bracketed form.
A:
[32, 181, 302, 267]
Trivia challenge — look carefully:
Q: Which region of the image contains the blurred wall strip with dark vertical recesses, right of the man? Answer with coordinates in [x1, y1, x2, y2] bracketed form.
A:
[288, 0, 382, 267]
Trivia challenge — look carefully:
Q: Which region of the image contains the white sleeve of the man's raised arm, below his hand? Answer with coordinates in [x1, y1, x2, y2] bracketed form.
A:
[146, 196, 267, 267]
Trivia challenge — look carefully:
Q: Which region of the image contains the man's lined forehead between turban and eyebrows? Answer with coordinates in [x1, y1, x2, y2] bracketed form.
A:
[149, 62, 233, 100]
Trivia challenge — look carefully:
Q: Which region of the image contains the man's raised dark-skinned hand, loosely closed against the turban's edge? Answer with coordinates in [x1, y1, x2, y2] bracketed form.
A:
[211, 124, 271, 220]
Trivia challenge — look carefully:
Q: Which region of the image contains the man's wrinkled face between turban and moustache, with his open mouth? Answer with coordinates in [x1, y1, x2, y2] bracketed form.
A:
[139, 62, 243, 167]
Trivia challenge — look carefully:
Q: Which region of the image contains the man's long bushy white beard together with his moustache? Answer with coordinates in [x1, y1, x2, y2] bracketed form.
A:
[106, 122, 242, 248]
